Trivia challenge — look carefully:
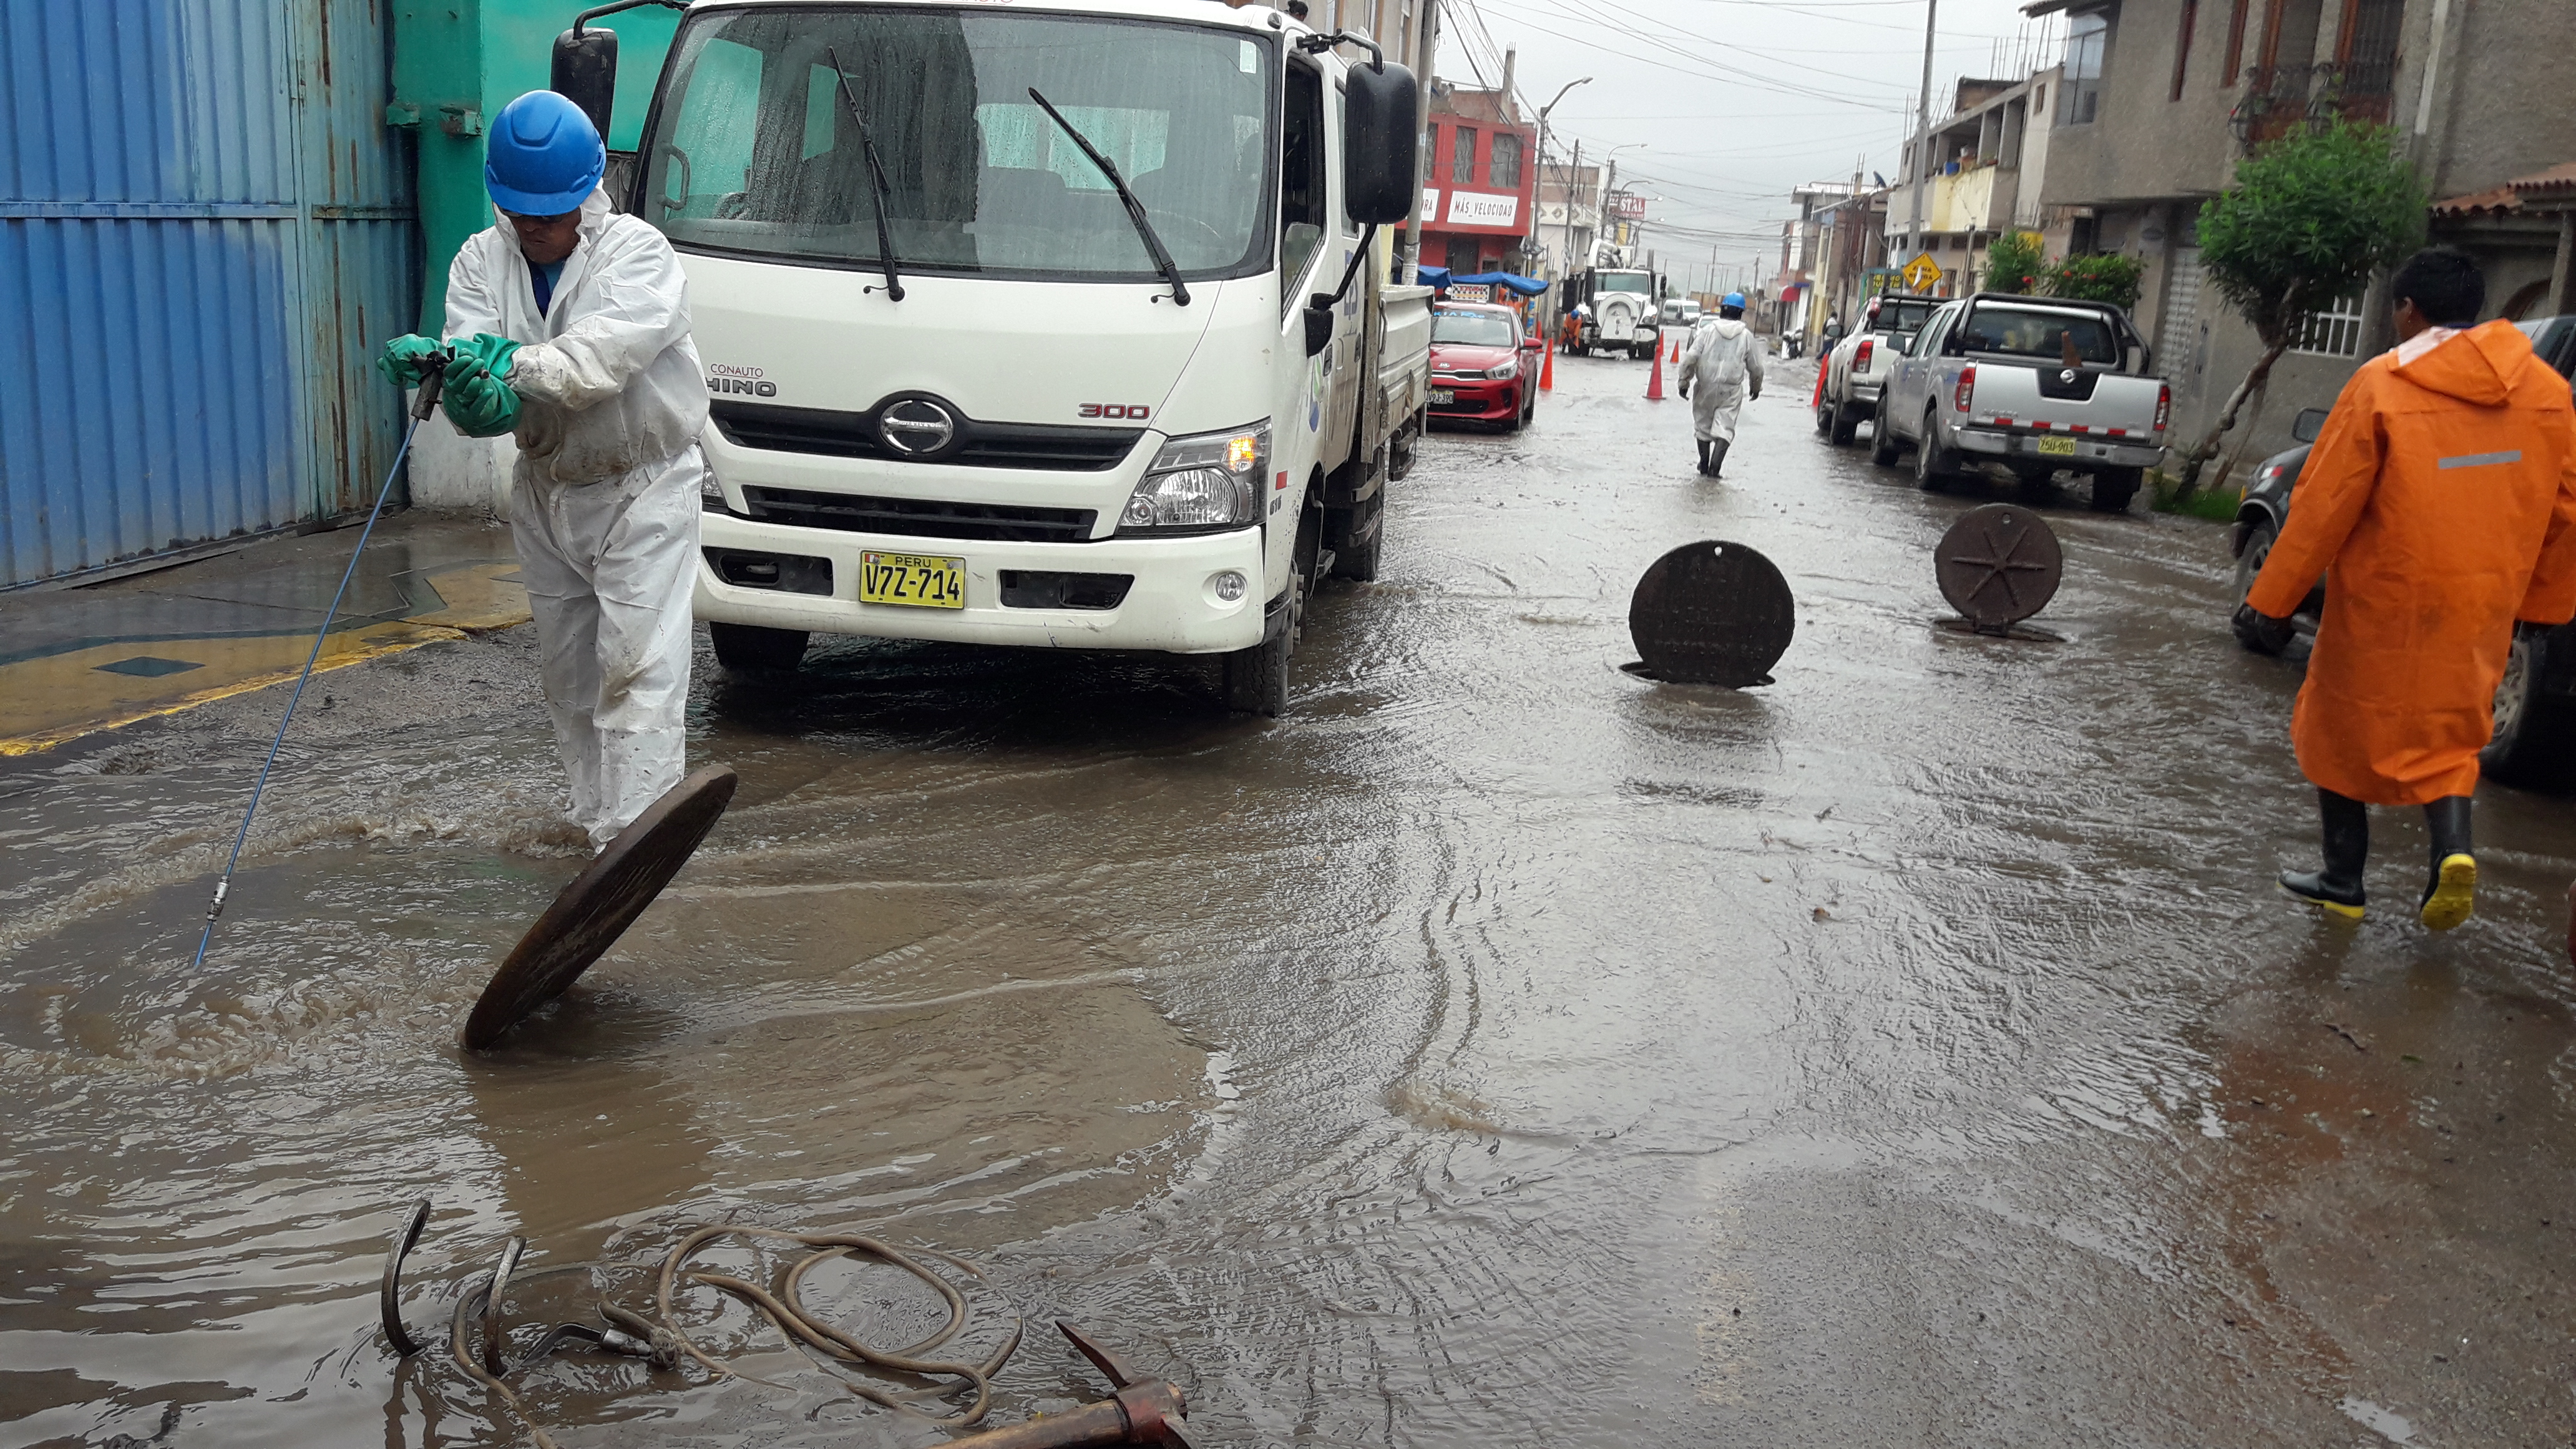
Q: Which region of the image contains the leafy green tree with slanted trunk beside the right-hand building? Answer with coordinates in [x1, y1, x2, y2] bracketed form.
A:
[2179, 121, 2429, 497]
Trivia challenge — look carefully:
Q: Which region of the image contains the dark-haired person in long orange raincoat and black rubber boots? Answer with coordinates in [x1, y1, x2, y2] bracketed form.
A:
[2243, 248, 2576, 931]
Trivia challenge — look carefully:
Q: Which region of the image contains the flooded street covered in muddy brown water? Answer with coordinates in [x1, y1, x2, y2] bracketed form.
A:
[0, 358, 2576, 1447]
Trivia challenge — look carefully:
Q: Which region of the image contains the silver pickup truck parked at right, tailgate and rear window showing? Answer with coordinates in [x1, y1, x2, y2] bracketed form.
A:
[1870, 291, 2174, 513]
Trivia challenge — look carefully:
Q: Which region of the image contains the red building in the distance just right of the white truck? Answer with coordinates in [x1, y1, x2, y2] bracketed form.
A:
[1422, 80, 1538, 273]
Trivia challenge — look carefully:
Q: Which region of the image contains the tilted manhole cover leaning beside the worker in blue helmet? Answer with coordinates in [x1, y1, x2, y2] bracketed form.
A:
[464, 766, 737, 1052]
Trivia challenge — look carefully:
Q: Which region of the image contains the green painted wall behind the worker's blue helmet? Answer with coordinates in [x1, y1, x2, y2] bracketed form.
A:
[386, 0, 680, 335]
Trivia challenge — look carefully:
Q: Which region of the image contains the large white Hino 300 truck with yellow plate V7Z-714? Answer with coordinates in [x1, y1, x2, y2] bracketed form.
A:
[554, 0, 1430, 714]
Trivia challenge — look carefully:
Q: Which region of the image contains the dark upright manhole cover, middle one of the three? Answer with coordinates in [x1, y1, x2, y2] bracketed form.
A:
[1628, 539, 1798, 688]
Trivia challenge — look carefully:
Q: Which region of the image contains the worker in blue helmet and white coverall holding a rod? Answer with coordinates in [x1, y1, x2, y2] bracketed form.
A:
[379, 90, 706, 851]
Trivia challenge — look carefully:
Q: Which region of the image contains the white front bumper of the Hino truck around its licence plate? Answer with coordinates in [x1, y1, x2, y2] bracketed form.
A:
[696, 513, 1265, 655]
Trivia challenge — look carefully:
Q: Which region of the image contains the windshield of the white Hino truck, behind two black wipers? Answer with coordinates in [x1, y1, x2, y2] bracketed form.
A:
[639, 5, 1277, 281]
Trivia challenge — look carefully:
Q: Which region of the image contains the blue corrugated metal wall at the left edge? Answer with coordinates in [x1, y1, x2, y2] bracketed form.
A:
[0, 0, 420, 588]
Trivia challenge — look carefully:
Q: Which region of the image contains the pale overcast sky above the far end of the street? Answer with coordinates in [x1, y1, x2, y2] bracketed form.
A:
[1435, 0, 2064, 283]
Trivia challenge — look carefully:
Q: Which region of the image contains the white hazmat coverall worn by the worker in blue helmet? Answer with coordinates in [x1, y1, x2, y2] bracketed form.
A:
[448, 191, 706, 848]
